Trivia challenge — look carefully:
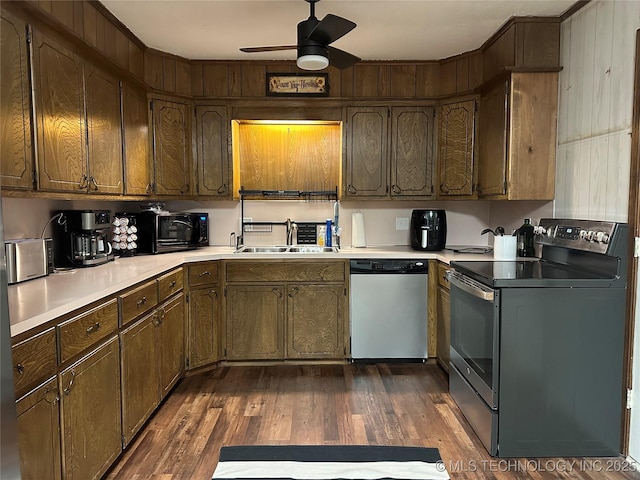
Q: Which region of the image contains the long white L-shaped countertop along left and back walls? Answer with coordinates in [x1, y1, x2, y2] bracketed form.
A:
[8, 246, 493, 337]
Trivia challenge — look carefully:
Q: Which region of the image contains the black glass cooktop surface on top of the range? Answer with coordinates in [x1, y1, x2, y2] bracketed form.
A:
[451, 260, 617, 287]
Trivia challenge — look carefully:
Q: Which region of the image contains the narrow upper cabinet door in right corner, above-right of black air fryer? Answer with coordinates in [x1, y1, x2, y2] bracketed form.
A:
[438, 100, 476, 197]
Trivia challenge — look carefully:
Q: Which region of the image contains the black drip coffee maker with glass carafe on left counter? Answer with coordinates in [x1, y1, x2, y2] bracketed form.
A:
[52, 210, 114, 267]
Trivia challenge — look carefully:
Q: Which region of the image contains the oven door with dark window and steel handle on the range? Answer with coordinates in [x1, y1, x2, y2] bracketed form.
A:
[448, 270, 500, 410]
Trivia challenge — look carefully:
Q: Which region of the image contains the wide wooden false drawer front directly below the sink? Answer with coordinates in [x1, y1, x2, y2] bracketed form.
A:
[226, 261, 345, 282]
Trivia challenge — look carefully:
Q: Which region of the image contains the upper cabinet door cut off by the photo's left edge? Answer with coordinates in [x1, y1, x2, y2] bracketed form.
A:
[0, 10, 34, 189]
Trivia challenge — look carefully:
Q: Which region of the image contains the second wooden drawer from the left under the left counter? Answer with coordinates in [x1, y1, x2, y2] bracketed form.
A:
[58, 298, 118, 363]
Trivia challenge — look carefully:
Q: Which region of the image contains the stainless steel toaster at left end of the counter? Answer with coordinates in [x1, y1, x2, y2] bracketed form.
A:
[4, 238, 53, 285]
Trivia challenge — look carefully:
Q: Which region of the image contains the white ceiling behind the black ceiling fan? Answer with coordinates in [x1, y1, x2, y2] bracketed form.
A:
[102, 0, 575, 60]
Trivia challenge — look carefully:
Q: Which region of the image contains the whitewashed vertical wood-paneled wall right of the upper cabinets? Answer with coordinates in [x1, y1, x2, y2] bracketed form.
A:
[554, 0, 640, 222]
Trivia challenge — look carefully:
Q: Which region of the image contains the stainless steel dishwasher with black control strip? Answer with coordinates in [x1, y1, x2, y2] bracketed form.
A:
[350, 259, 428, 362]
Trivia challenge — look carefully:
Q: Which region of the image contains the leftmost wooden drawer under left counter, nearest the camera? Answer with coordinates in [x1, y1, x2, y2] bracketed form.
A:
[11, 328, 56, 397]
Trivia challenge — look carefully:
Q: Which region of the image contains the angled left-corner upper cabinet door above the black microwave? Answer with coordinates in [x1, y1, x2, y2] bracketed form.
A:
[152, 100, 191, 195]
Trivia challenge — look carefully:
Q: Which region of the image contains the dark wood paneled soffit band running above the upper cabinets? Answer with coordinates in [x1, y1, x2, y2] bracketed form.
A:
[2, 0, 560, 100]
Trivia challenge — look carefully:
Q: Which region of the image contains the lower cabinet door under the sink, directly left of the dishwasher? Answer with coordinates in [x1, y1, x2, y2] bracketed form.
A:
[287, 285, 346, 359]
